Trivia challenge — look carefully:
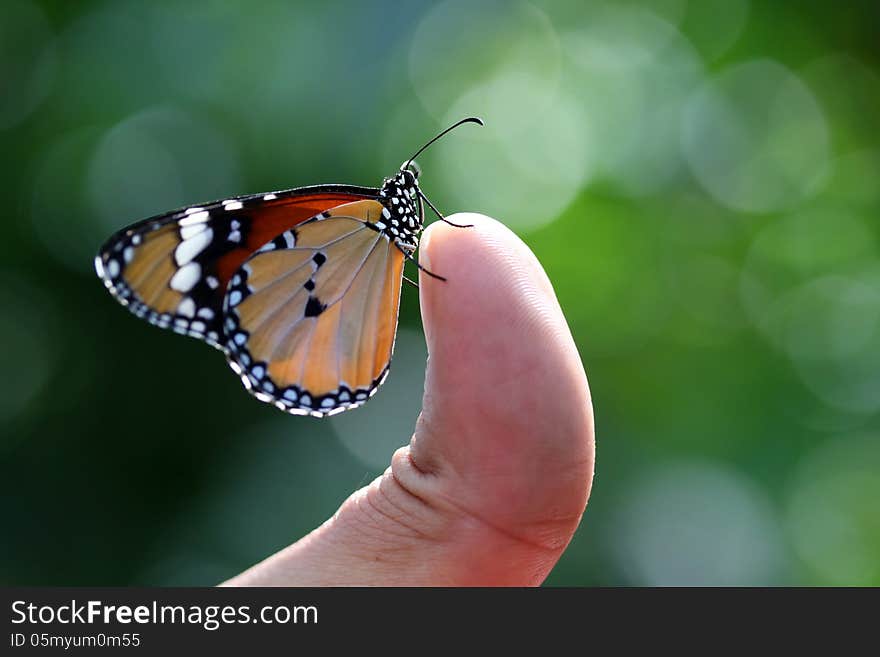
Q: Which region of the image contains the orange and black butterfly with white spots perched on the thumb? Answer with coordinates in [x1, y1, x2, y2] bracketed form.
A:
[95, 117, 483, 417]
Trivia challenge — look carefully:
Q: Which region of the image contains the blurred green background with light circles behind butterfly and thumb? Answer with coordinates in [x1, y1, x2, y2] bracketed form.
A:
[0, 0, 880, 585]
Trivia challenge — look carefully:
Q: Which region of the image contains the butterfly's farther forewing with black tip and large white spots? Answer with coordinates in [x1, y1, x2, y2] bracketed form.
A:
[95, 185, 377, 349]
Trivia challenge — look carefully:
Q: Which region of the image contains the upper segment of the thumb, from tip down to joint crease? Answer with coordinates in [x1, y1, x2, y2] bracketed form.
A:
[396, 214, 593, 564]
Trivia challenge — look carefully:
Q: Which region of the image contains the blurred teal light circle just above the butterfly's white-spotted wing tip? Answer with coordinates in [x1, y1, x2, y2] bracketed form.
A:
[88, 107, 242, 237]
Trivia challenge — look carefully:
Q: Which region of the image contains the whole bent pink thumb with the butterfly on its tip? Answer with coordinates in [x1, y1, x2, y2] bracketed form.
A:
[224, 214, 594, 586]
